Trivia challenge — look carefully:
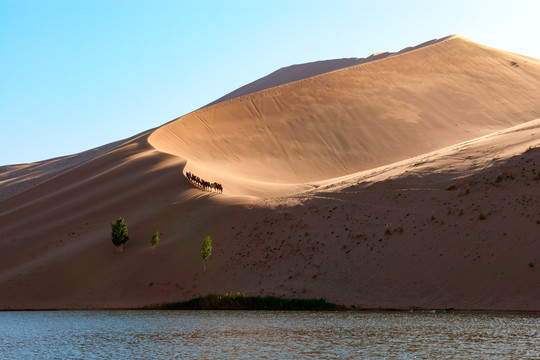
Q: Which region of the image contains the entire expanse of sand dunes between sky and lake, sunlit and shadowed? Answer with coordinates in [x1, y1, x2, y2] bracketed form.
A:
[0, 36, 540, 311]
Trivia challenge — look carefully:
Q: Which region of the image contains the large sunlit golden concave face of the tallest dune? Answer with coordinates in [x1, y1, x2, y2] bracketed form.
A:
[149, 36, 540, 188]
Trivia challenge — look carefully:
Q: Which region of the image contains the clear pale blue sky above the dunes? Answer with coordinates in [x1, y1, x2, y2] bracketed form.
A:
[0, 0, 540, 165]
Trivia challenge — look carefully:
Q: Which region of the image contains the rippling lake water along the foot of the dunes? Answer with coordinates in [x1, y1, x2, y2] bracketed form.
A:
[0, 311, 540, 359]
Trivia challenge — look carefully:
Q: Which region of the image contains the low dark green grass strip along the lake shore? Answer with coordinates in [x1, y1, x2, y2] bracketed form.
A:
[146, 293, 342, 310]
